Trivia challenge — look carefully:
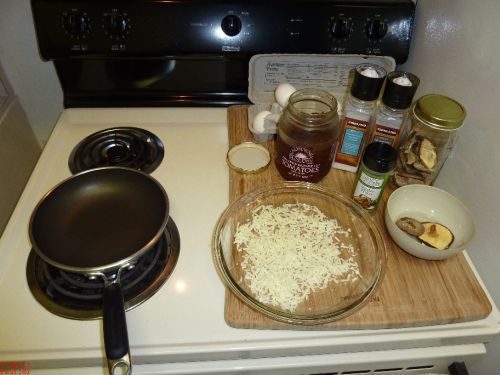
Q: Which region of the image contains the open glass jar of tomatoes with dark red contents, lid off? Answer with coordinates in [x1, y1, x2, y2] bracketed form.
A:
[275, 88, 339, 182]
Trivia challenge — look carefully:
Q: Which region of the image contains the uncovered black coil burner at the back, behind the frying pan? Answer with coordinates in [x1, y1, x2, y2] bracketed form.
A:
[68, 127, 163, 174]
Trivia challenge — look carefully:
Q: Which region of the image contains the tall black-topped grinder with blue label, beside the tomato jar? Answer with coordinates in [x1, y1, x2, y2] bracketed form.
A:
[333, 64, 386, 172]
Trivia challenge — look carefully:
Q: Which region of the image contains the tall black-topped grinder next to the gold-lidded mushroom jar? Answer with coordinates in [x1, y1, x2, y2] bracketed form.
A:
[368, 71, 420, 148]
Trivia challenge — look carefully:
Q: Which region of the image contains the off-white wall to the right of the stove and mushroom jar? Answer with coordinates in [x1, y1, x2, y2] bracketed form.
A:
[403, 0, 500, 375]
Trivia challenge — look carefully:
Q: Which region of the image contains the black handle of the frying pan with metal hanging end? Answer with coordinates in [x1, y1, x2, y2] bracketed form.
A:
[102, 281, 132, 375]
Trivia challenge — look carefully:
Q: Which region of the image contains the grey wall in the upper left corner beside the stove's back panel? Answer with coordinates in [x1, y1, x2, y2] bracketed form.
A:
[0, 0, 63, 145]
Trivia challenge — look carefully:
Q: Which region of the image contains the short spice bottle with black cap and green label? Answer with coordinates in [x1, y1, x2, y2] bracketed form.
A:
[352, 142, 397, 213]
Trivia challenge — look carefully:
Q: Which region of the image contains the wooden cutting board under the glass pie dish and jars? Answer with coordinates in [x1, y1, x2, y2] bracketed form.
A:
[224, 106, 491, 330]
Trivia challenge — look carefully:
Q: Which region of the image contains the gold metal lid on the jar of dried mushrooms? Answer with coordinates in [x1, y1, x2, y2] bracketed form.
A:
[413, 94, 467, 130]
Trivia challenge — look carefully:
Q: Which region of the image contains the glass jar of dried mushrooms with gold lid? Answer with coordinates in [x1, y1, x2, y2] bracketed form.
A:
[392, 94, 466, 186]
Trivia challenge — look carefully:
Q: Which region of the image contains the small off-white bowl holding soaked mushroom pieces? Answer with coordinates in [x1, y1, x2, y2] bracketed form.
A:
[385, 185, 476, 260]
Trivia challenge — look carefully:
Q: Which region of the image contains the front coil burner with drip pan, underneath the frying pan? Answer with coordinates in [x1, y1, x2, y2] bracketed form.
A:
[26, 220, 180, 320]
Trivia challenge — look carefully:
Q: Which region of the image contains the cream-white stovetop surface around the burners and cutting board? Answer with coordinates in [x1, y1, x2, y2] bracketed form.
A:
[0, 108, 500, 374]
